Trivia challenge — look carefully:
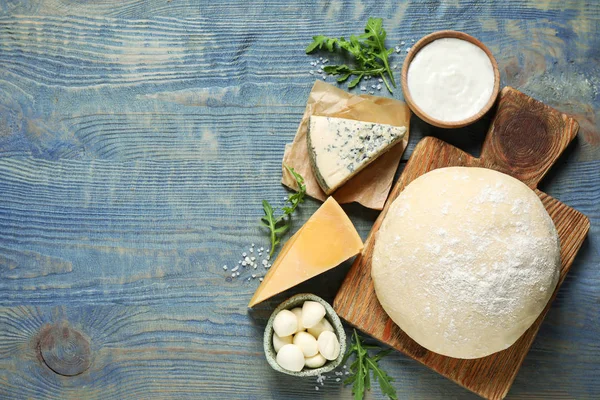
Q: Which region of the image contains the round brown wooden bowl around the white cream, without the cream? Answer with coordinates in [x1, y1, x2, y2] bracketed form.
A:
[401, 31, 500, 129]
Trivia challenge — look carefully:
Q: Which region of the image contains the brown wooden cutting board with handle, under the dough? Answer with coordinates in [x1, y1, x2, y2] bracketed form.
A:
[333, 87, 590, 399]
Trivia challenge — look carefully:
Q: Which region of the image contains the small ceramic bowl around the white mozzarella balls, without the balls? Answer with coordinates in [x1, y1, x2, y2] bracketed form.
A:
[263, 293, 346, 377]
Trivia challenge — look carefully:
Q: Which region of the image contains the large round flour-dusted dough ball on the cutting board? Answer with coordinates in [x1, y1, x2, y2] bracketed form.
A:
[371, 167, 560, 359]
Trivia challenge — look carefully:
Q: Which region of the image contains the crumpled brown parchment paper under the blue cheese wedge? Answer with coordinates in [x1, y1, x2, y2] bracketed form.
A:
[281, 81, 410, 210]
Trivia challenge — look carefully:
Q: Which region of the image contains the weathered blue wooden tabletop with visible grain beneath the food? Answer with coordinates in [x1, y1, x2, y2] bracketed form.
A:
[0, 0, 600, 399]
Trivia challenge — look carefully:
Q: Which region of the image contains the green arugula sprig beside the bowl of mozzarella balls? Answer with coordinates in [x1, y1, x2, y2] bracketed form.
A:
[342, 329, 398, 400]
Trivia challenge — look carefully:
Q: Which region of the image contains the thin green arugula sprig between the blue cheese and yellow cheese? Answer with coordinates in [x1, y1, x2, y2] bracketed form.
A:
[260, 165, 306, 257]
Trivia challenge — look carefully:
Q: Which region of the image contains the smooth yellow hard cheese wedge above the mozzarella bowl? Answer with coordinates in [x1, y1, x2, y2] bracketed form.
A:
[248, 197, 363, 307]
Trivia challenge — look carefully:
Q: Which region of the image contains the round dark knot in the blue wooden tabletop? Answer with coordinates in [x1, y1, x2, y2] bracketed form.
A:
[38, 322, 91, 376]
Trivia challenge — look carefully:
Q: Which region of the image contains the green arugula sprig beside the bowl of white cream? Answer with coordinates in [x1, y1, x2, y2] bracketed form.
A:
[306, 18, 396, 93]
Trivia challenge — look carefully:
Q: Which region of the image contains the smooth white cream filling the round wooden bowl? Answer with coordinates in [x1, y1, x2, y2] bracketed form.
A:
[405, 37, 499, 127]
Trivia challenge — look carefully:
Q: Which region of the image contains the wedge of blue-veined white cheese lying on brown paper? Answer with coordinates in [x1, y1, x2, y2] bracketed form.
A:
[307, 116, 406, 195]
